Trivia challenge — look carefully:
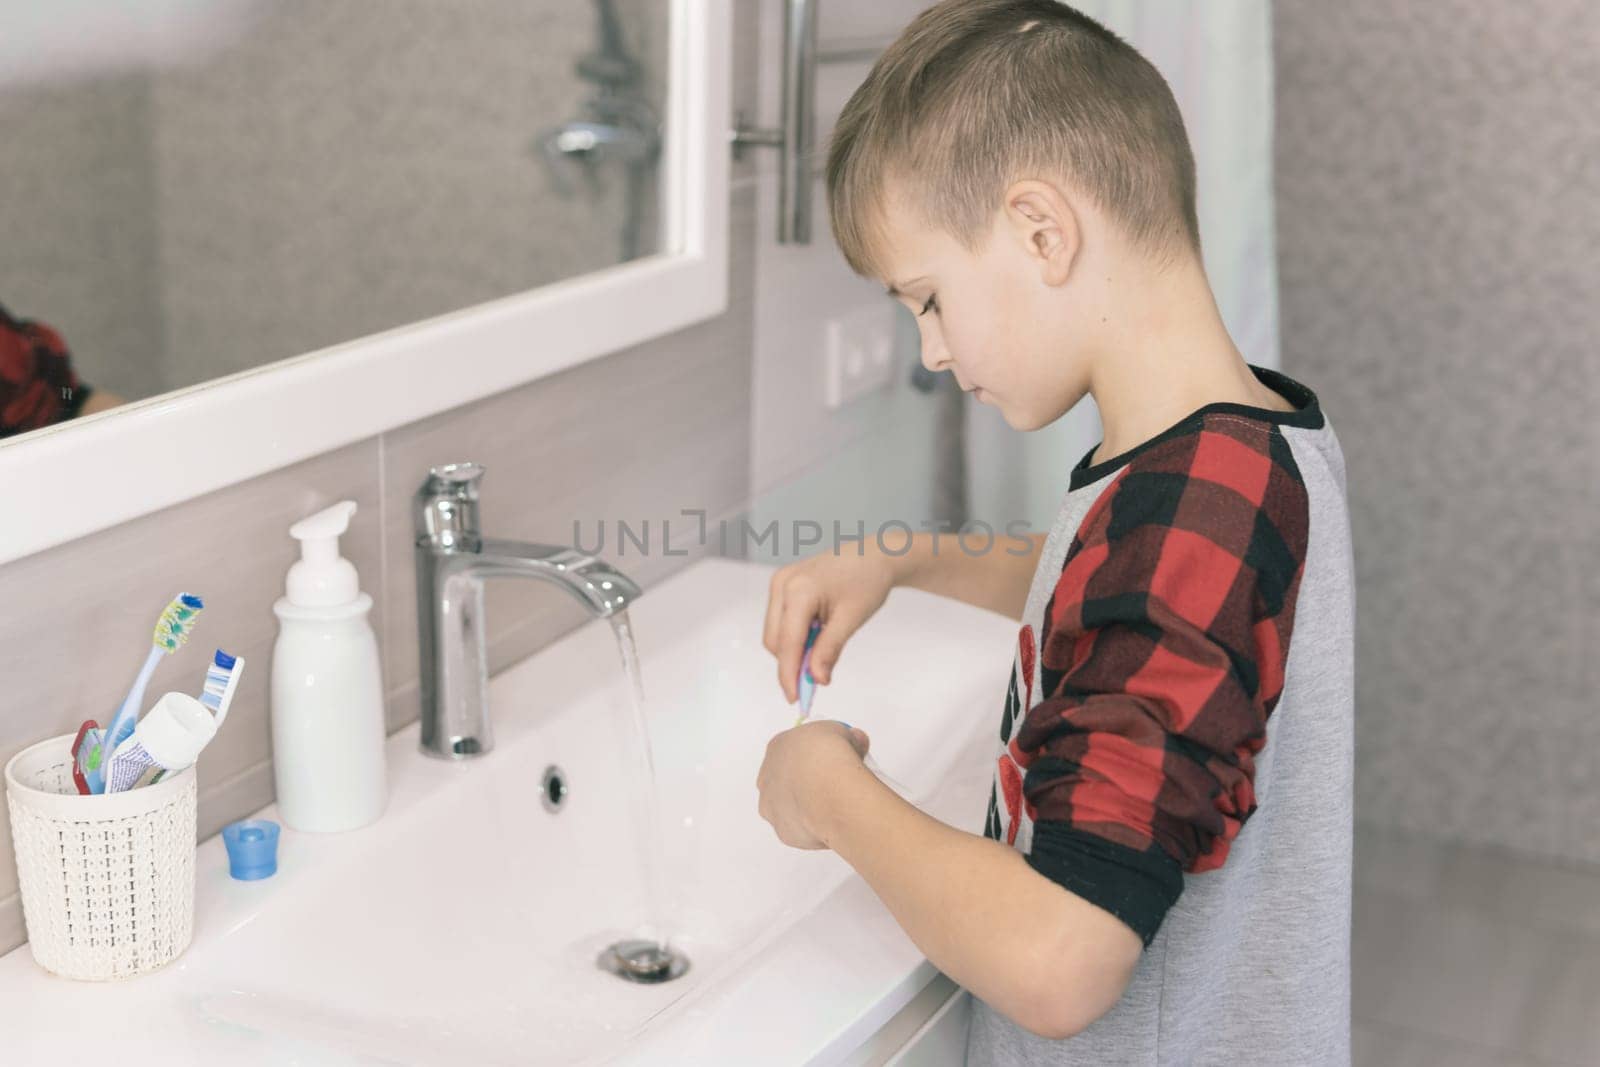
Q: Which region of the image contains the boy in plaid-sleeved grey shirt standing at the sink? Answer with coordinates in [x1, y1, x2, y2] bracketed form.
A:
[757, 0, 1354, 1065]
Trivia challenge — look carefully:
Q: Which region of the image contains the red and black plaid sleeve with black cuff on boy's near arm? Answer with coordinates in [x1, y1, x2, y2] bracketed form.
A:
[1011, 416, 1309, 947]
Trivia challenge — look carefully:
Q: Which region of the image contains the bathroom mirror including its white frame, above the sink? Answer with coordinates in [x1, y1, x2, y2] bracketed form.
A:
[0, 0, 730, 561]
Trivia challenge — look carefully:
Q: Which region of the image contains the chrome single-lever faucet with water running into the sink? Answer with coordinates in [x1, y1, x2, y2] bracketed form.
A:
[413, 462, 640, 760]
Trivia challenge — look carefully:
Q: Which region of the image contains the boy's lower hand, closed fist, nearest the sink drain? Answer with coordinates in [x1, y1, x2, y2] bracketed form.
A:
[755, 718, 870, 849]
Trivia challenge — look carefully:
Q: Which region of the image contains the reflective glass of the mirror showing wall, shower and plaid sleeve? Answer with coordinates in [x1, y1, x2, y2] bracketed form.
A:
[0, 0, 670, 442]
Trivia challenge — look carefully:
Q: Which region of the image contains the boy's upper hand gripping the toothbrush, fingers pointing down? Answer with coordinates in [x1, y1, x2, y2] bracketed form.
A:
[762, 552, 894, 704]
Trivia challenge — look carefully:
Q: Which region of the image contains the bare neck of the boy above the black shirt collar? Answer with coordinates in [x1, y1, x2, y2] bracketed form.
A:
[1090, 261, 1294, 464]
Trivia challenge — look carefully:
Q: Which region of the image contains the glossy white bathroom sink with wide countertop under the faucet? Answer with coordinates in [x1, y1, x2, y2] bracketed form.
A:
[0, 560, 1014, 1067]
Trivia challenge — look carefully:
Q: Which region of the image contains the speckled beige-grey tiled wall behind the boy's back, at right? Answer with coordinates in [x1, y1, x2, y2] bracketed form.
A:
[1274, 0, 1600, 862]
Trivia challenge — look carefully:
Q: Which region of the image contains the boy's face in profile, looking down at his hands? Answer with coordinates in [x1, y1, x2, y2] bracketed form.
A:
[883, 178, 1088, 430]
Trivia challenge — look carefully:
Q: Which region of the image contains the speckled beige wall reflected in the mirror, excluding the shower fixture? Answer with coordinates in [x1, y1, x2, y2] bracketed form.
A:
[155, 0, 667, 391]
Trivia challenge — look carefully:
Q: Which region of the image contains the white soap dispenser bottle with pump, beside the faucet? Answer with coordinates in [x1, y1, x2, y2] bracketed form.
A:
[272, 501, 389, 832]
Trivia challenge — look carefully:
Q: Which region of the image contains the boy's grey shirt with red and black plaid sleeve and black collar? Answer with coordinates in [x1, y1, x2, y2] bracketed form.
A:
[966, 366, 1355, 1067]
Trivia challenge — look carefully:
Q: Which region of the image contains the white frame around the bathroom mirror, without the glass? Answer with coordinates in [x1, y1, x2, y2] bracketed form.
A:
[0, 0, 733, 563]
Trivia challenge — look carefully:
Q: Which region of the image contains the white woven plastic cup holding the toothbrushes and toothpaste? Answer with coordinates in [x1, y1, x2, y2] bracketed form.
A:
[5, 733, 195, 981]
